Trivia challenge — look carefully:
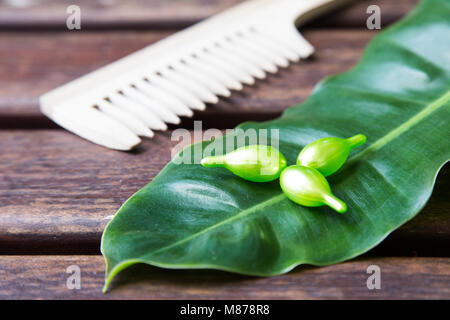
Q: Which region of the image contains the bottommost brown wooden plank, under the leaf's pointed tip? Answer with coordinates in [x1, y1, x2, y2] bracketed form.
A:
[0, 256, 450, 300]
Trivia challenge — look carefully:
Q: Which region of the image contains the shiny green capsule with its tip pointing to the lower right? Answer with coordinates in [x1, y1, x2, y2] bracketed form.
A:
[280, 165, 347, 213]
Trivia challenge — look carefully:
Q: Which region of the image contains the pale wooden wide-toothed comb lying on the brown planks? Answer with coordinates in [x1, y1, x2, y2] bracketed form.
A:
[40, 0, 342, 150]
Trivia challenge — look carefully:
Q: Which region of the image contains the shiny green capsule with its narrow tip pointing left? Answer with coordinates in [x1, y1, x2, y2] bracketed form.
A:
[202, 145, 286, 182]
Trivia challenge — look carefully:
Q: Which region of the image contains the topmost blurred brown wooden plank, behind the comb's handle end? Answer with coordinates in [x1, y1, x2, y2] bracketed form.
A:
[0, 0, 418, 30]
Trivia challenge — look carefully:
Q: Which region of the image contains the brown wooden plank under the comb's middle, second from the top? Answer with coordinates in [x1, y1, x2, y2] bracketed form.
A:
[0, 30, 376, 128]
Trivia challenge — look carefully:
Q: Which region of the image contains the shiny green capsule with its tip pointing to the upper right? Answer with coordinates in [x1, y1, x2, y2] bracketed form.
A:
[297, 134, 367, 177]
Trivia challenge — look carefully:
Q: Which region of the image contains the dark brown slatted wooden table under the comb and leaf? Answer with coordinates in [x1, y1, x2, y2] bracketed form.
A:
[0, 0, 450, 299]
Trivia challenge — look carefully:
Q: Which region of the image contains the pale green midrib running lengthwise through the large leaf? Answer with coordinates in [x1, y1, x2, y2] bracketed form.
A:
[145, 90, 450, 258]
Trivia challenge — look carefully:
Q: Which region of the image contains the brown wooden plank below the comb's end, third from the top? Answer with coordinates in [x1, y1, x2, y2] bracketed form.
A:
[0, 130, 450, 256]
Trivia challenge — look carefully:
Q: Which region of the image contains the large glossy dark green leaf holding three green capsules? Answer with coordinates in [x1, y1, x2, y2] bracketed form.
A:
[102, 0, 450, 289]
